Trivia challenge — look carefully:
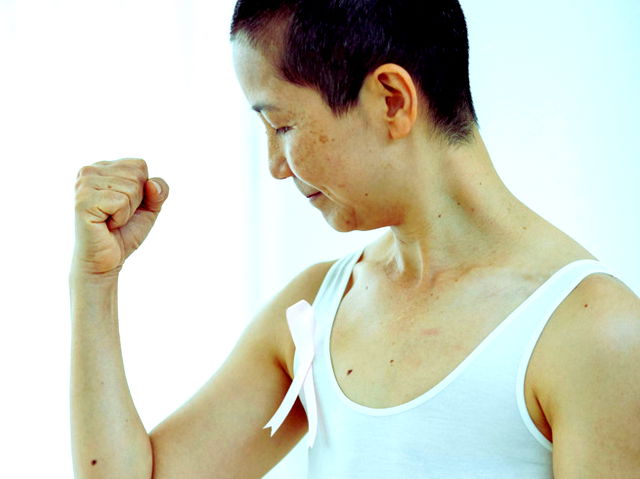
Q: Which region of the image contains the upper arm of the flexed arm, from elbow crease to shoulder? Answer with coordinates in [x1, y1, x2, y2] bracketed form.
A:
[150, 262, 332, 479]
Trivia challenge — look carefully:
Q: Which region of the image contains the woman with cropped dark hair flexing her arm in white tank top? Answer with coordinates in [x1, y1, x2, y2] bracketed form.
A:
[70, 0, 640, 478]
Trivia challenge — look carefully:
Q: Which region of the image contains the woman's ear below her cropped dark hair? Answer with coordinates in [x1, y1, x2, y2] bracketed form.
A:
[366, 63, 418, 139]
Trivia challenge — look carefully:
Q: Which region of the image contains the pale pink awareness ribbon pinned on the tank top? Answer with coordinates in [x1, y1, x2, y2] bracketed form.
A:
[263, 300, 318, 447]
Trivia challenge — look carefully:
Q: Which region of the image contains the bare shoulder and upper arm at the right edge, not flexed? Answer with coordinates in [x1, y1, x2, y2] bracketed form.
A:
[541, 274, 640, 479]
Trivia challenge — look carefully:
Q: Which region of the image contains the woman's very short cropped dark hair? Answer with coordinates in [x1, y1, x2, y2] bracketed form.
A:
[231, 0, 478, 144]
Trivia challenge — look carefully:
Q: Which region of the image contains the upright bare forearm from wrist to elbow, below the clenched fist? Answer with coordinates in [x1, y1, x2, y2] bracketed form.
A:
[69, 274, 153, 479]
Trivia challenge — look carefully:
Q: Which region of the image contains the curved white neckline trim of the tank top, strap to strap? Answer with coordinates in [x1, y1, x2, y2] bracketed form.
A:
[322, 251, 602, 416]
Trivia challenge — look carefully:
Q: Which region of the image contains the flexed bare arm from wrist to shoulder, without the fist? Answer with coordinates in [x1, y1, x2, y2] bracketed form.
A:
[71, 262, 332, 479]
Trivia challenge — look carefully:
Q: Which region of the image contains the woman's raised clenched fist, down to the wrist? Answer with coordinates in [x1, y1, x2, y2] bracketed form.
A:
[72, 158, 169, 275]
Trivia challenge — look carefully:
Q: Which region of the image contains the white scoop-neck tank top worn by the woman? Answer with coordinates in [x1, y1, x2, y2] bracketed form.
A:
[294, 249, 613, 479]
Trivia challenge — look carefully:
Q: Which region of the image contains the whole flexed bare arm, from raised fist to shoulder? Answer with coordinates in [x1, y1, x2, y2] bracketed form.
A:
[69, 160, 332, 479]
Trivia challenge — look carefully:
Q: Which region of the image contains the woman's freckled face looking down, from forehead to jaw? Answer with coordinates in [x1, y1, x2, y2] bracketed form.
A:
[233, 40, 400, 231]
